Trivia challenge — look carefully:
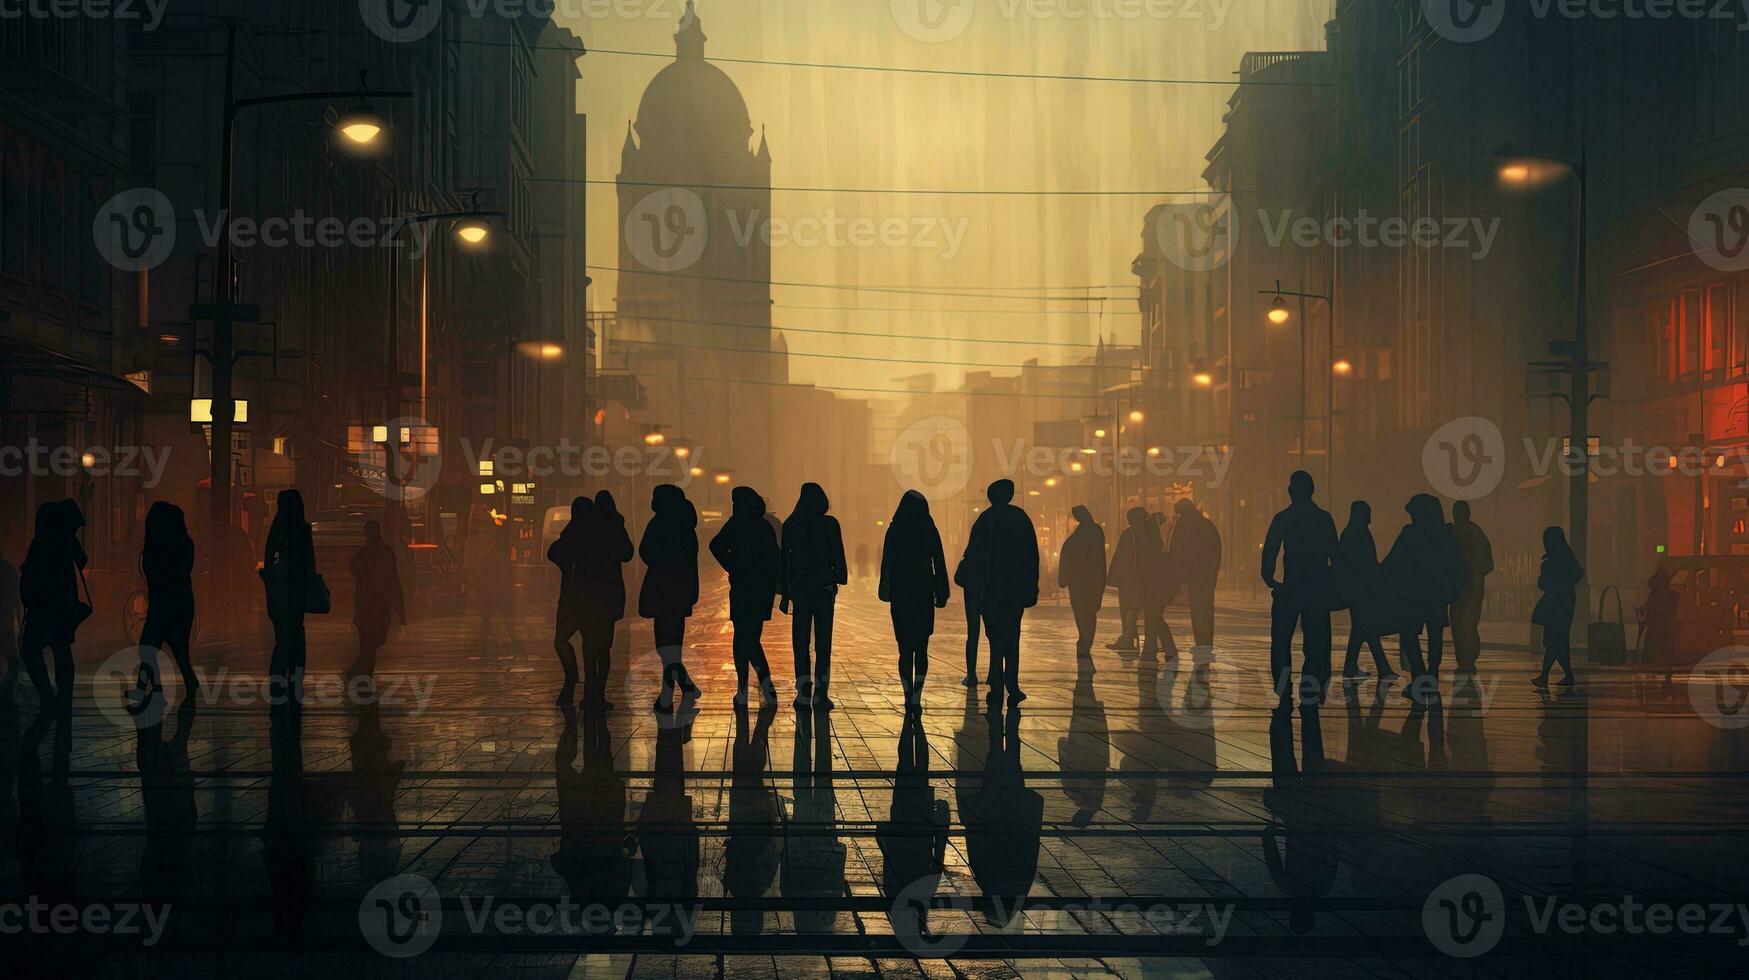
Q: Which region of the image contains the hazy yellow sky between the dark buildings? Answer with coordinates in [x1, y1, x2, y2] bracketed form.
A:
[556, 0, 1331, 394]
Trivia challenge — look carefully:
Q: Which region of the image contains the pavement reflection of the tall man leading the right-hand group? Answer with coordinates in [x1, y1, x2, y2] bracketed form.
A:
[1261, 704, 1355, 936]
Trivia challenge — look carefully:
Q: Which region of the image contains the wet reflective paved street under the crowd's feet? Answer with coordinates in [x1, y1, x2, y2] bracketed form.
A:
[0, 583, 1749, 977]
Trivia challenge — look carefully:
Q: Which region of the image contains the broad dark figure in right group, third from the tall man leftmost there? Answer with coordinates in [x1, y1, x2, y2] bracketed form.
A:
[1382, 494, 1464, 702]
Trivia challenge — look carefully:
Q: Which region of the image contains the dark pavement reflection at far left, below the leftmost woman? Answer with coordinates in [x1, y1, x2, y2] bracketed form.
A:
[17, 711, 79, 905]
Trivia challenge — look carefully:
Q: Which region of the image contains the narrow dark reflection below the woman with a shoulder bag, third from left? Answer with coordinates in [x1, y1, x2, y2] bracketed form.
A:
[261, 698, 313, 938]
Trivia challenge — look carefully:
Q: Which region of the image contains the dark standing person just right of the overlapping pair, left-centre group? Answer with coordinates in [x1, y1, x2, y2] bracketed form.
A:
[638, 483, 698, 711]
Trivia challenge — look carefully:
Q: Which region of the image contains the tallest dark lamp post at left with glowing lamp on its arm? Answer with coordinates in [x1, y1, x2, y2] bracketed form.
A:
[208, 23, 413, 602]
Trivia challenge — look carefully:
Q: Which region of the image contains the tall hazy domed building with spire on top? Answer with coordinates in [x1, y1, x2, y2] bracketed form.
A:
[607, 2, 787, 483]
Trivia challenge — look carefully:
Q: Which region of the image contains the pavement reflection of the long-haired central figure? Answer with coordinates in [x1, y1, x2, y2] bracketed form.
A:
[875, 714, 948, 942]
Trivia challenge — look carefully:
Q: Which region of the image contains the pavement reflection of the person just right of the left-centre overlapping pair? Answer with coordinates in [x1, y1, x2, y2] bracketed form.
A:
[638, 714, 698, 936]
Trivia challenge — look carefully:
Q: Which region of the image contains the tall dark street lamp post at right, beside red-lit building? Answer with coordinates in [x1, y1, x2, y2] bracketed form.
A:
[1494, 141, 1595, 577]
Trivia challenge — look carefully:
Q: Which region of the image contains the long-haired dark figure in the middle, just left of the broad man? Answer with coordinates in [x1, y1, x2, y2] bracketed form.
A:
[878, 490, 948, 711]
